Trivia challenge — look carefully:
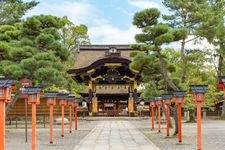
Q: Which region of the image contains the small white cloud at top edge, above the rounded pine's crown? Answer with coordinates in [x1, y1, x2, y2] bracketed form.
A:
[128, 0, 160, 9]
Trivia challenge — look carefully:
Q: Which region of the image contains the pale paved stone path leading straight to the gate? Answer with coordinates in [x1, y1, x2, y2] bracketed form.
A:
[74, 120, 159, 150]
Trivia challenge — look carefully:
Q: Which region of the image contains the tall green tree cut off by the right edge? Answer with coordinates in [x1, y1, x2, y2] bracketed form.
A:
[198, 0, 225, 118]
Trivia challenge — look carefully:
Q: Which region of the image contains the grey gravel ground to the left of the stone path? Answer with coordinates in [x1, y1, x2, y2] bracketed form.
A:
[6, 120, 96, 150]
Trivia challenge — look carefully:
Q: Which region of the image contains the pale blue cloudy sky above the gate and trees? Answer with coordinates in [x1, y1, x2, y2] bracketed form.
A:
[24, 0, 214, 48]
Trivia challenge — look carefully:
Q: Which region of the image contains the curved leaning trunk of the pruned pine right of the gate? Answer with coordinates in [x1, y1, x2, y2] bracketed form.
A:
[157, 49, 178, 135]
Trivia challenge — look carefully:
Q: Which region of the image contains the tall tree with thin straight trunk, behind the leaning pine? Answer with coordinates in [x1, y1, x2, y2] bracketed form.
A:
[163, 0, 208, 83]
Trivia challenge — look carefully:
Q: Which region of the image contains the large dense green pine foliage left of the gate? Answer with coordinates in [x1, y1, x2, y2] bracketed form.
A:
[0, 15, 89, 92]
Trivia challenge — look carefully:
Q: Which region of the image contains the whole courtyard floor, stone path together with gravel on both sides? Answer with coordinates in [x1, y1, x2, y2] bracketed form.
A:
[6, 117, 225, 150]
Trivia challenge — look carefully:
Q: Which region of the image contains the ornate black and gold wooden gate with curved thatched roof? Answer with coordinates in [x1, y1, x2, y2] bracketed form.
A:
[68, 45, 141, 116]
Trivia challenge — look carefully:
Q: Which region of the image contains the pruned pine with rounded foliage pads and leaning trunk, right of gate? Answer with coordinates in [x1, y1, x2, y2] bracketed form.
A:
[131, 8, 186, 134]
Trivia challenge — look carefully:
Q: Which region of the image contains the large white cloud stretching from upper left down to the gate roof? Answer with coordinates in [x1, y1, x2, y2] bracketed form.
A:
[26, 1, 141, 44]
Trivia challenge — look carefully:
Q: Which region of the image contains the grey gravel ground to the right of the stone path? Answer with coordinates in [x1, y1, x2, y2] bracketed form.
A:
[133, 118, 225, 150]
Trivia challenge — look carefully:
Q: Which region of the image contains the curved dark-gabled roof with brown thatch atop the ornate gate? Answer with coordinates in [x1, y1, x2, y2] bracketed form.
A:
[67, 45, 140, 84]
